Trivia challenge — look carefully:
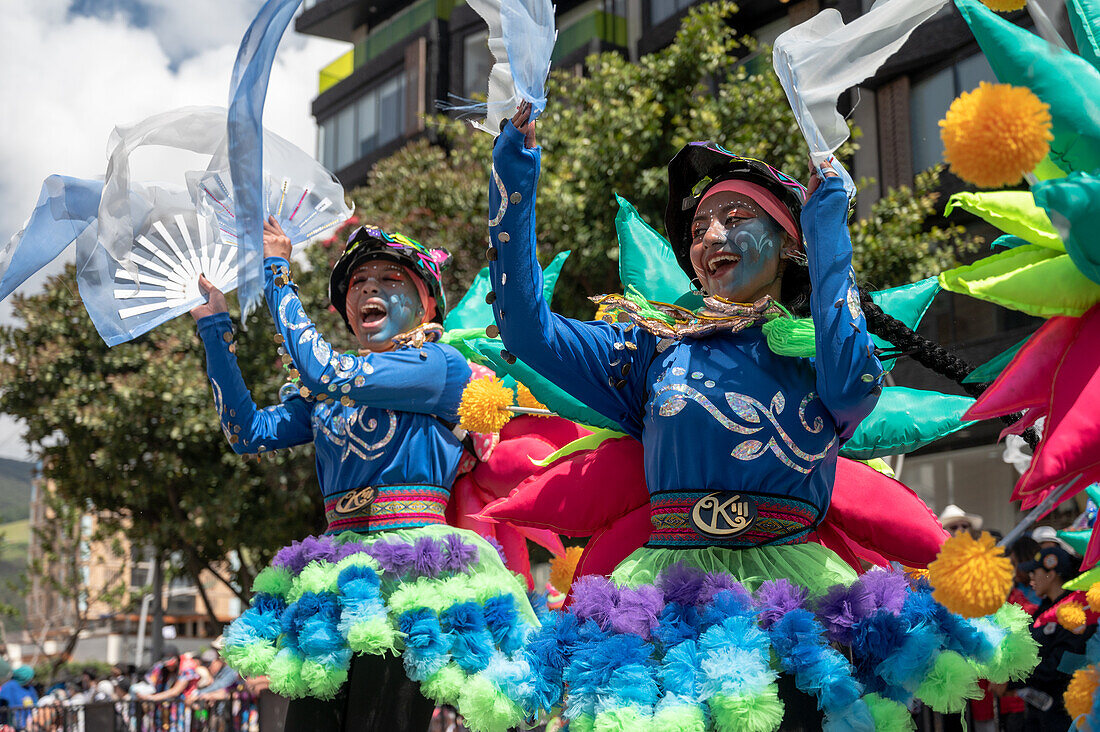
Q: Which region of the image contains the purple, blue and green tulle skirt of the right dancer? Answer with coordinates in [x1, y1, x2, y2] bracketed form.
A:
[527, 544, 1037, 732]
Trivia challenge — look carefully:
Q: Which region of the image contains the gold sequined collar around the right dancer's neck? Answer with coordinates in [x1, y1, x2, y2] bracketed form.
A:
[590, 295, 783, 340]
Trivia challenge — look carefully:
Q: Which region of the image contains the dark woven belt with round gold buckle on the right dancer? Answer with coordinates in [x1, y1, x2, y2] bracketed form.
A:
[646, 491, 821, 548]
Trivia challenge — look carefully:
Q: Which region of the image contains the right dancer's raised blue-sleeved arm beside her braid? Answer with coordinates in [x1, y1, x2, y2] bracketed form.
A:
[802, 176, 882, 439]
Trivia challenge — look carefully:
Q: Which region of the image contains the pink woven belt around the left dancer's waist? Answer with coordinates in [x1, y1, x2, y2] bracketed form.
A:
[325, 485, 451, 534]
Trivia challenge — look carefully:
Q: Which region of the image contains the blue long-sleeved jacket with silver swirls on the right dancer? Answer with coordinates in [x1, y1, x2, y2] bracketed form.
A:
[490, 122, 882, 515]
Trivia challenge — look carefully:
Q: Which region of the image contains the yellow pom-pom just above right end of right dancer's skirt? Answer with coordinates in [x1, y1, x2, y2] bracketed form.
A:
[928, 532, 1013, 618]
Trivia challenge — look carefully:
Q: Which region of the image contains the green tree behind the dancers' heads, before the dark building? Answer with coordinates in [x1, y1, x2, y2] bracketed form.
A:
[352, 1, 974, 316]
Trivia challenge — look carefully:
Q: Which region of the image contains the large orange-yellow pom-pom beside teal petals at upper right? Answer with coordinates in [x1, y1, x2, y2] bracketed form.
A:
[939, 81, 1054, 188]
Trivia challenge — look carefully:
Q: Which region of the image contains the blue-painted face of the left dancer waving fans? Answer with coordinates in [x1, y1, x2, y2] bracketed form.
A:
[345, 261, 424, 351]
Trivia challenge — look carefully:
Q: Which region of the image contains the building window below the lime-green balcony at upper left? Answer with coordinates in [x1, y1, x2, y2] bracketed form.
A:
[318, 72, 405, 171]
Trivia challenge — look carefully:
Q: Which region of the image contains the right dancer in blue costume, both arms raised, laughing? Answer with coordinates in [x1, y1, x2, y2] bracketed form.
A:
[488, 105, 1034, 732]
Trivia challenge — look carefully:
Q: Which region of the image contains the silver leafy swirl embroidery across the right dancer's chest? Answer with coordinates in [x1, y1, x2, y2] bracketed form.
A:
[653, 384, 837, 473]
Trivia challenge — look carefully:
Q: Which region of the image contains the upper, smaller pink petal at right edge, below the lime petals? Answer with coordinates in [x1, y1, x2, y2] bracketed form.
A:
[963, 317, 1078, 419]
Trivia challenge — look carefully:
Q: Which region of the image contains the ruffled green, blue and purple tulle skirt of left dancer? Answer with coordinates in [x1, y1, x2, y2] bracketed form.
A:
[222, 524, 539, 732]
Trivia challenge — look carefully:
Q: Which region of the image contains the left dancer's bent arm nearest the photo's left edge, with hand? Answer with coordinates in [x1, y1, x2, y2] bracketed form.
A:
[191, 277, 314, 455]
